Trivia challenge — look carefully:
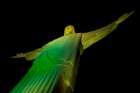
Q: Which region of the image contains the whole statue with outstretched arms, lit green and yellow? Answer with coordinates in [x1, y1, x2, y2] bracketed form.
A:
[10, 12, 133, 93]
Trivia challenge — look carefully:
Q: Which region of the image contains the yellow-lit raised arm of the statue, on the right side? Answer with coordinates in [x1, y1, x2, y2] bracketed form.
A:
[81, 11, 134, 49]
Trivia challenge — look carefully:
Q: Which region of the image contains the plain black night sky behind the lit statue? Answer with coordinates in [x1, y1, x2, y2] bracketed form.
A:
[0, 0, 138, 93]
